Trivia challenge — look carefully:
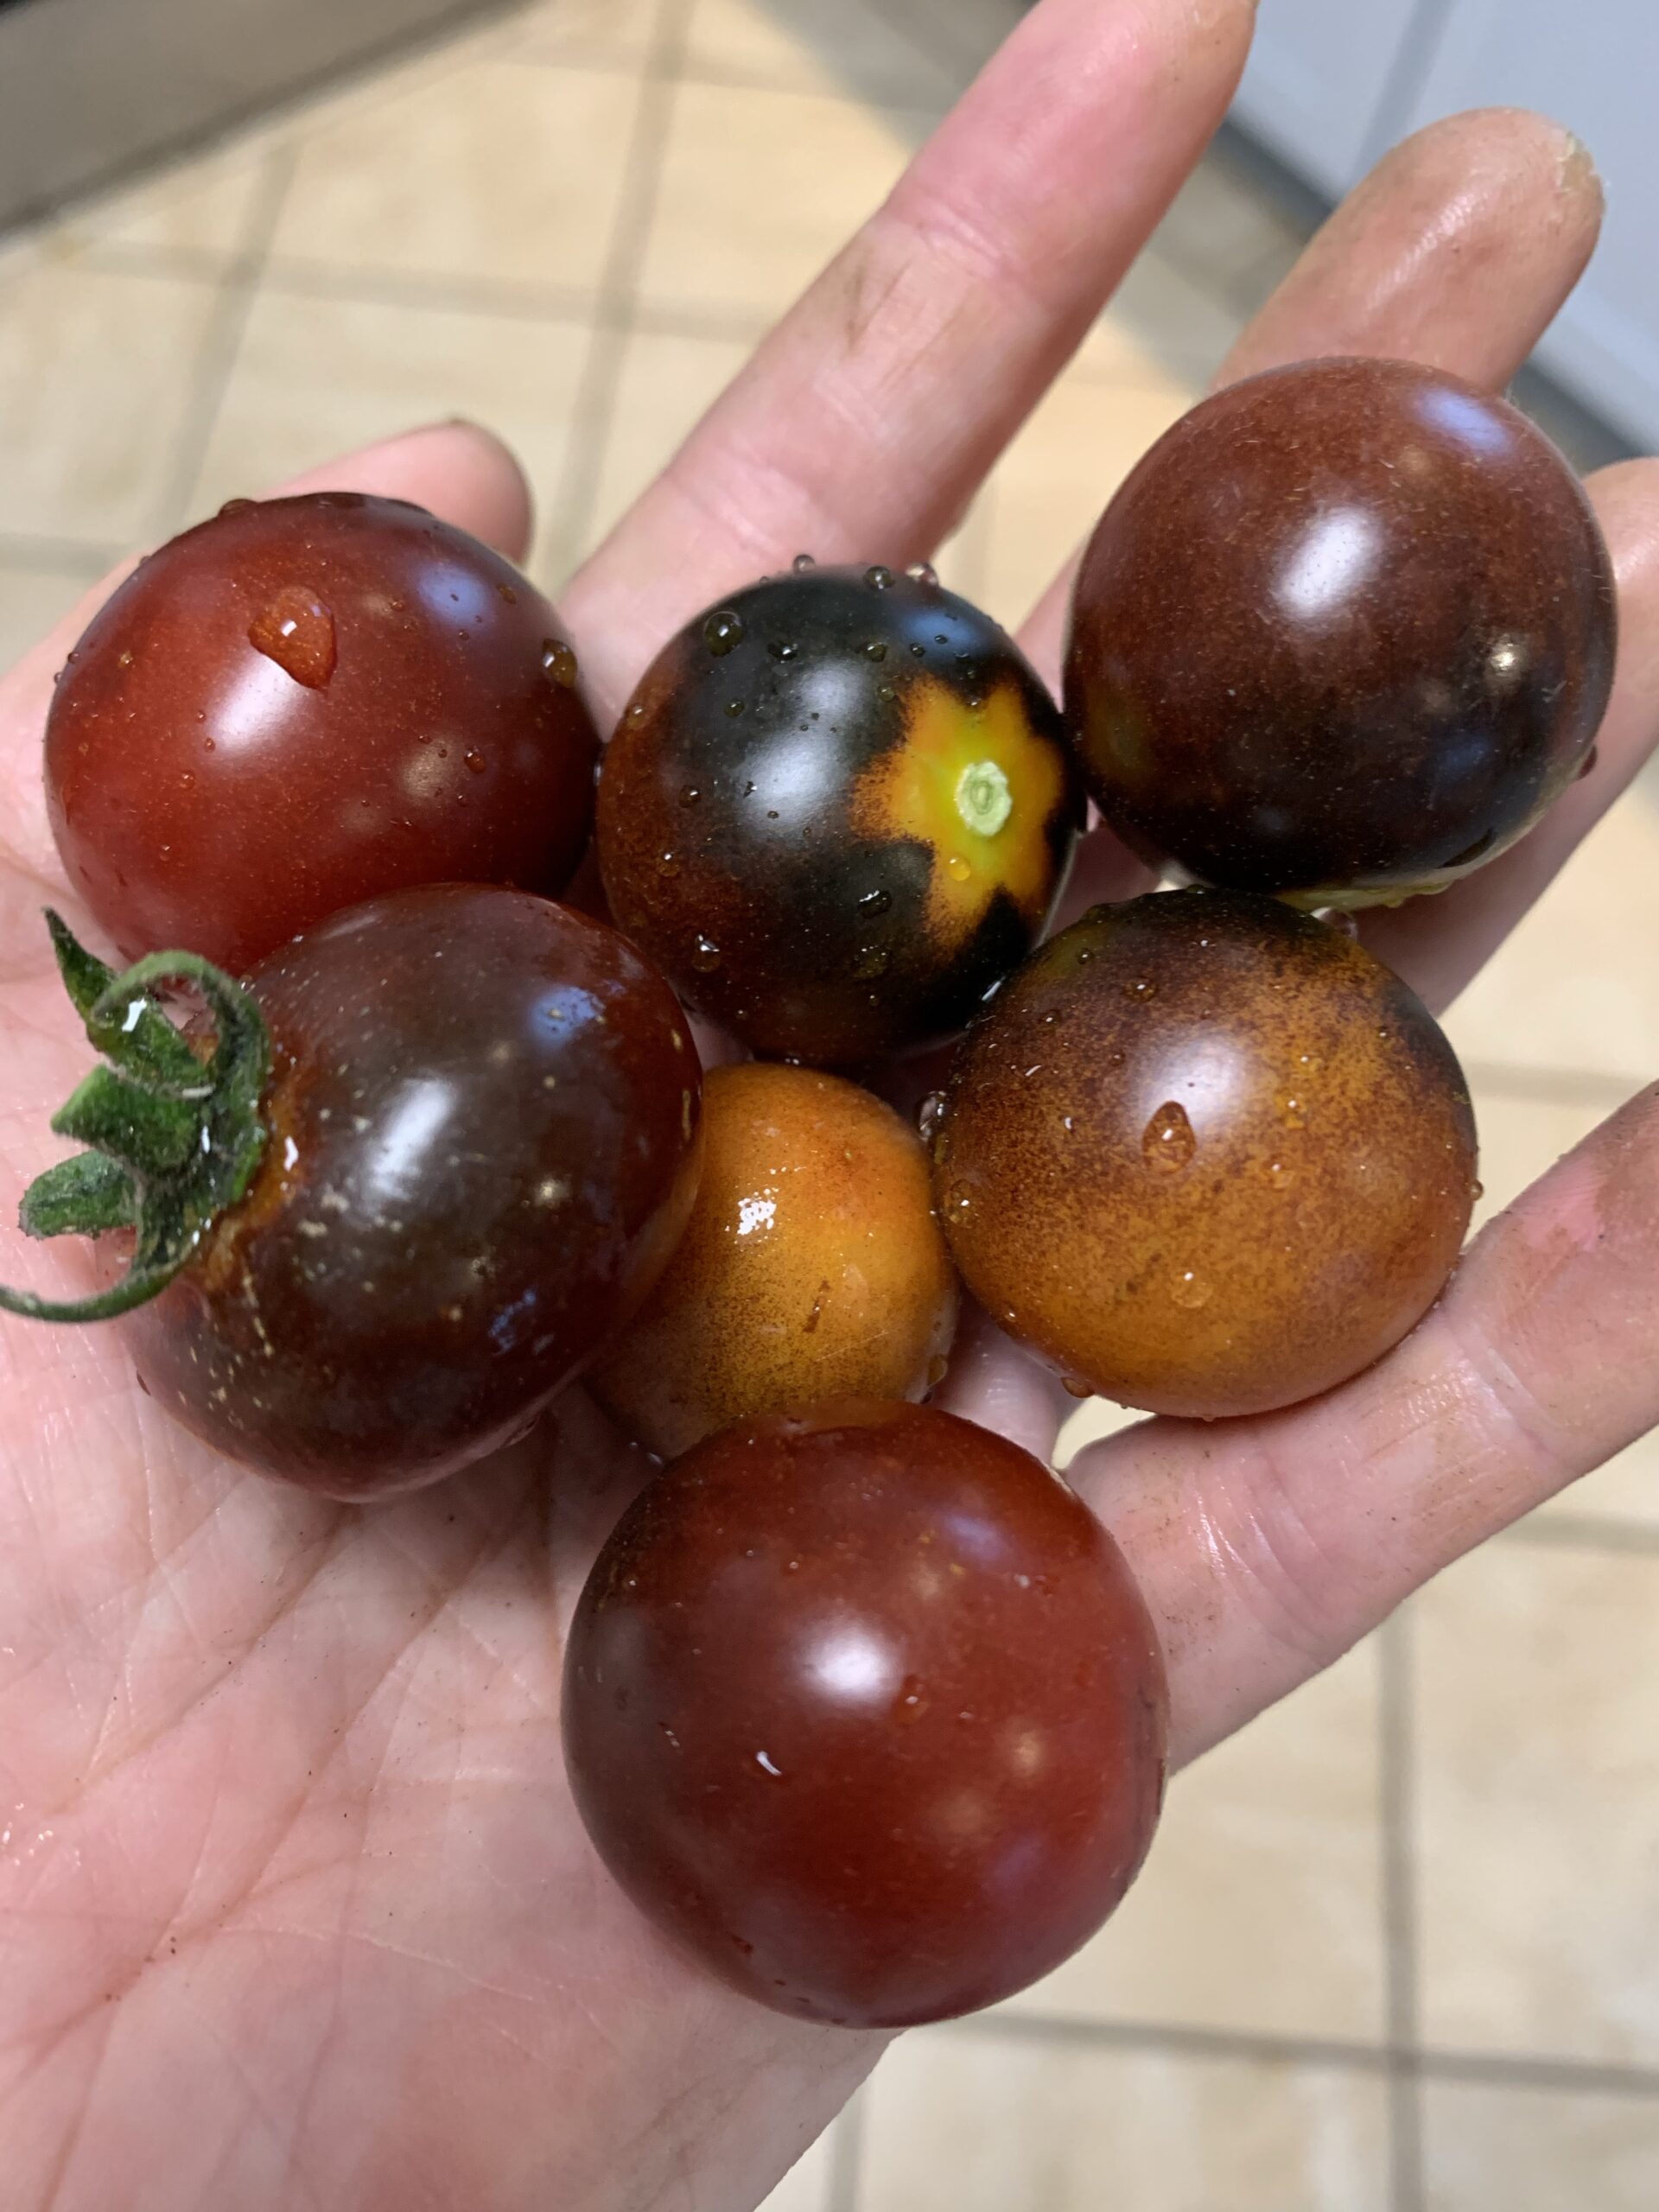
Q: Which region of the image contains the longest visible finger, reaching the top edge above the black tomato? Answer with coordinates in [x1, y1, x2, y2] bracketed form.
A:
[564, 0, 1255, 710]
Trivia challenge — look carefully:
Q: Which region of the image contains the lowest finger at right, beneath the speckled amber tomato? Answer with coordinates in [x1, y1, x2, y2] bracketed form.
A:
[1071, 1071, 1659, 1758]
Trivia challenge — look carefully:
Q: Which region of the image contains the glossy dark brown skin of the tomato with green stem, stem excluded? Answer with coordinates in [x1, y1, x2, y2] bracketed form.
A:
[126, 885, 699, 1497]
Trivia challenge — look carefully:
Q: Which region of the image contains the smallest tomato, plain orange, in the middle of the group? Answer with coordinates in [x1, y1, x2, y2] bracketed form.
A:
[591, 1062, 957, 1455]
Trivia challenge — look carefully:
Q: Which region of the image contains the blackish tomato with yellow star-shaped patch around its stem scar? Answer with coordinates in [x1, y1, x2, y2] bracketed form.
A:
[597, 566, 1082, 1064]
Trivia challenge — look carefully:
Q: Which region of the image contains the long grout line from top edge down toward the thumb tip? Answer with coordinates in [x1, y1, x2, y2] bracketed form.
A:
[553, 0, 692, 588]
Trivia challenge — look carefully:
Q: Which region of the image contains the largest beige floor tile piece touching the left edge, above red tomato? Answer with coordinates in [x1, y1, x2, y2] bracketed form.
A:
[0, 264, 217, 542]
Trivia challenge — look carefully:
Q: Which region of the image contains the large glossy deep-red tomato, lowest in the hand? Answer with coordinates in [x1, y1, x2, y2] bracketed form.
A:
[564, 1402, 1168, 2029]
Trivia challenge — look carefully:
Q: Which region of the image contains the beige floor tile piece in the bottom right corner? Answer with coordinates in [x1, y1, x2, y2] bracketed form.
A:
[1422, 2082, 1659, 2212]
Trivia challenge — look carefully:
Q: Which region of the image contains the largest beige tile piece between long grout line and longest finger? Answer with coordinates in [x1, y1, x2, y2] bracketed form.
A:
[639, 84, 927, 316]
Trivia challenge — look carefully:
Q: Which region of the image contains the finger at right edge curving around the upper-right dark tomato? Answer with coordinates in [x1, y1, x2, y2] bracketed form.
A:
[1363, 460, 1659, 1008]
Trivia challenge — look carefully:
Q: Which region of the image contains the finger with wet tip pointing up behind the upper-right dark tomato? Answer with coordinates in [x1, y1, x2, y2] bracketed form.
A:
[1020, 108, 1601, 909]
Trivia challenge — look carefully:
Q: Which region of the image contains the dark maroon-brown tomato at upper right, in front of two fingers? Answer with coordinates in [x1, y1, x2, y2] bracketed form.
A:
[1066, 360, 1615, 907]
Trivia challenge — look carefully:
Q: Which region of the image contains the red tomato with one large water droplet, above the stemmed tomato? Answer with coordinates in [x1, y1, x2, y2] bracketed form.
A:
[47, 491, 597, 973]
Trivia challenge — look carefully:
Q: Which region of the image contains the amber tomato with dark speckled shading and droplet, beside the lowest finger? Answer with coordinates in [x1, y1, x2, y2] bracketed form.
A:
[933, 892, 1476, 1418]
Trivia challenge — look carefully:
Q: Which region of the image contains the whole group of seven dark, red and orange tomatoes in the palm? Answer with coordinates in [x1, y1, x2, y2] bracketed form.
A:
[0, 360, 1615, 2024]
